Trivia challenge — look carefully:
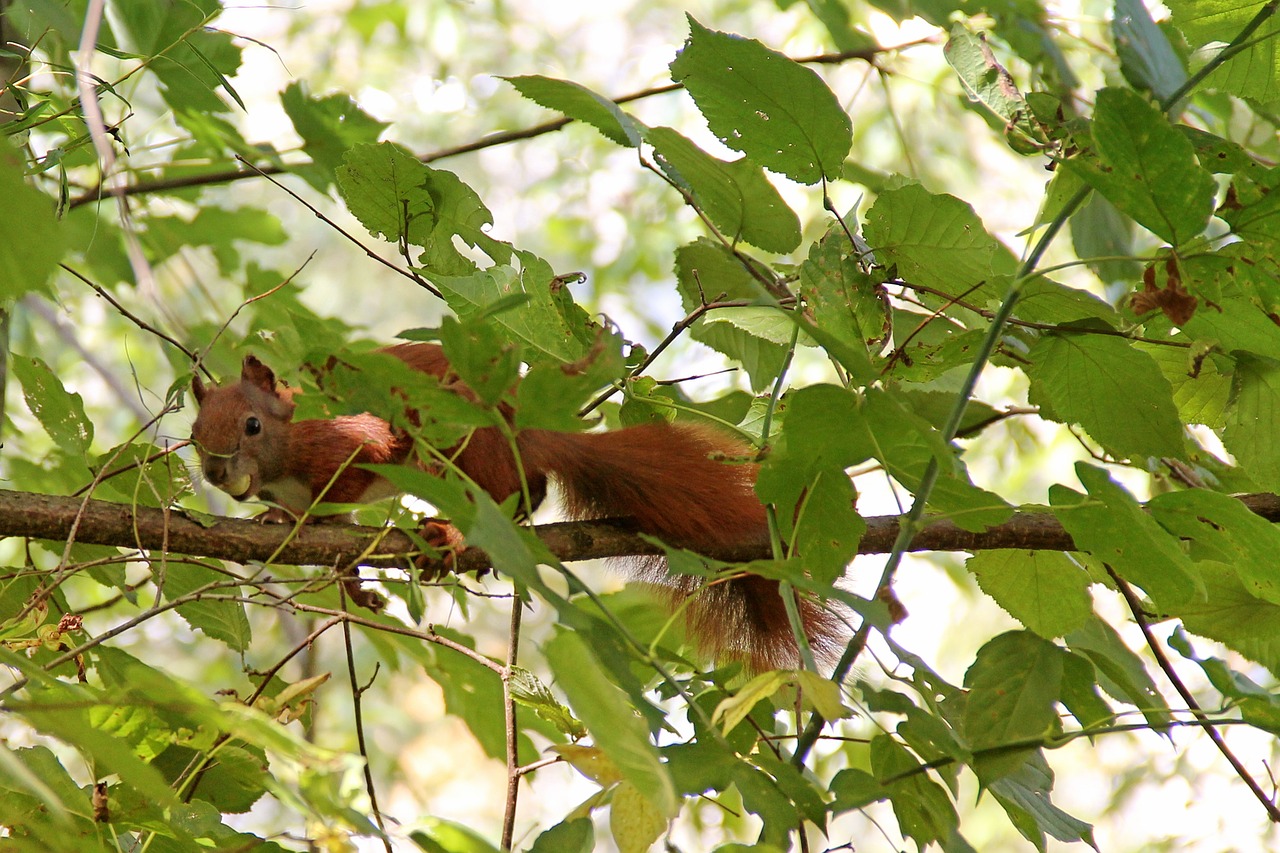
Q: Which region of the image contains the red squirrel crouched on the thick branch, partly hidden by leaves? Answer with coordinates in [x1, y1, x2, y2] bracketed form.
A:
[191, 343, 841, 671]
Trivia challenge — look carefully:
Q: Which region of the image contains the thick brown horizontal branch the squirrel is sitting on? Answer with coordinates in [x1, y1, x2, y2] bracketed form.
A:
[10, 489, 1280, 571]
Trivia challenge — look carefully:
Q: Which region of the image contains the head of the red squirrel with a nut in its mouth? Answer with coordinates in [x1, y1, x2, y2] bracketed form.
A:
[191, 356, 294, 501]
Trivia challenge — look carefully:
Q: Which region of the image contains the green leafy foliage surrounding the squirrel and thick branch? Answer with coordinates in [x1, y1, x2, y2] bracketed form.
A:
[0, 0, 1280, 853]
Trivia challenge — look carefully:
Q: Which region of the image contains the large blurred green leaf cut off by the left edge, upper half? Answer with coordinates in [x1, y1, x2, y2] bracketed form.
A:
[0, 153, 67, 301]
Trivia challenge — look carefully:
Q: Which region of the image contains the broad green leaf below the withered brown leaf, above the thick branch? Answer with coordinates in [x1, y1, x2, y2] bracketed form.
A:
[1027, 330, 1183, 457]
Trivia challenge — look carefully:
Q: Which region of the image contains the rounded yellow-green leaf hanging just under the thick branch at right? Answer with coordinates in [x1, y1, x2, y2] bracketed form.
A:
[965, 549, 1093, 639]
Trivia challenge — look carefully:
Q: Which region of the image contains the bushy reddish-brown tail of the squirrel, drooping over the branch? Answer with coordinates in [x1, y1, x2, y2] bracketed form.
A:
[521, 424, 844, 671]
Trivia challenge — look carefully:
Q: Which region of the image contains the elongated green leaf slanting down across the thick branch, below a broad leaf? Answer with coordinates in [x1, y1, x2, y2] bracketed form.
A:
[1048, 462, 1204, 607]
